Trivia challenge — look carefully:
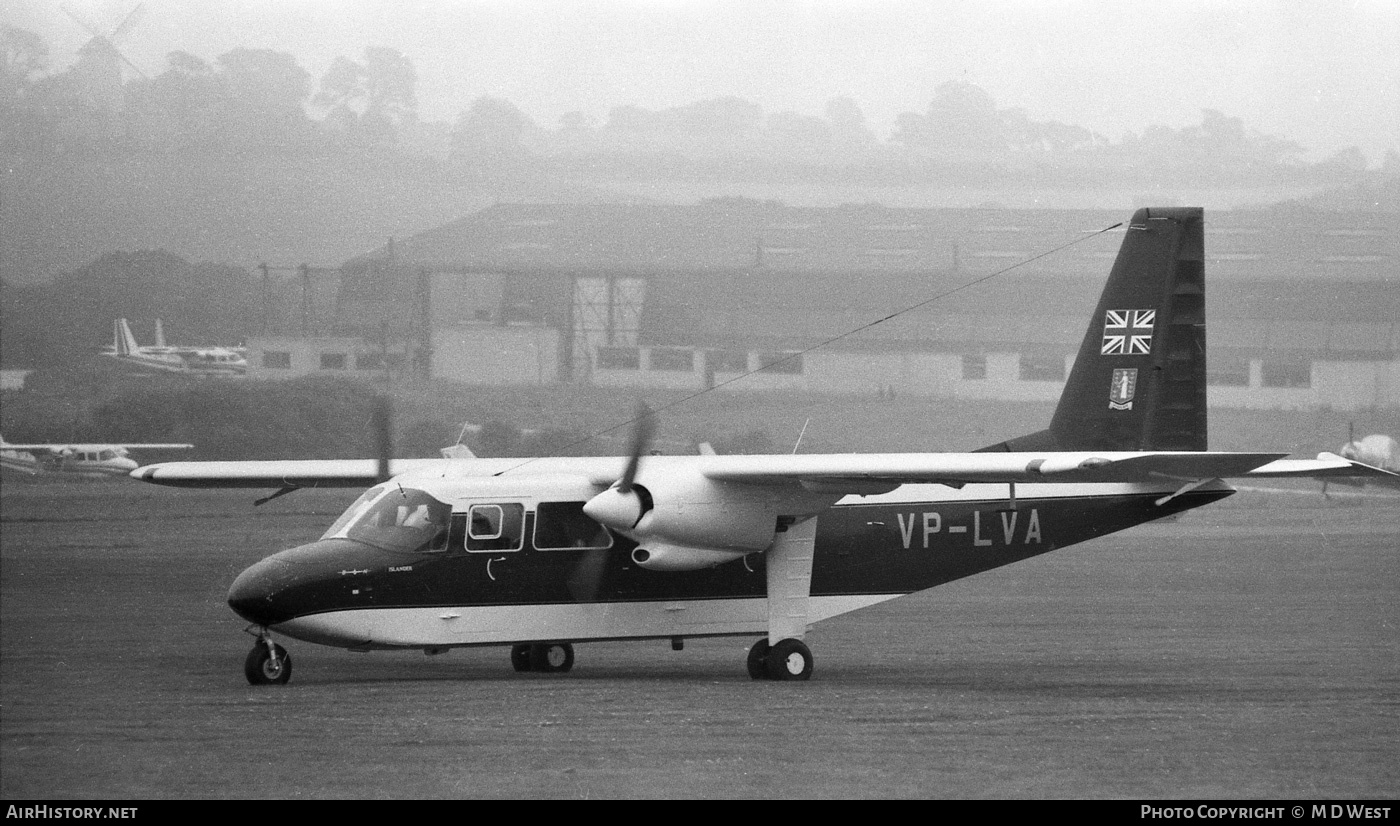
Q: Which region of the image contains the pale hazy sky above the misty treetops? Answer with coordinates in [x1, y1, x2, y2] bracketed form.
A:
[10, 0, 1400, 164]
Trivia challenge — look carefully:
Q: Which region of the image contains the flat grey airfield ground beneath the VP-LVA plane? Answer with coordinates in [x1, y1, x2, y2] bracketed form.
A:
[0, 482, 1400, 801]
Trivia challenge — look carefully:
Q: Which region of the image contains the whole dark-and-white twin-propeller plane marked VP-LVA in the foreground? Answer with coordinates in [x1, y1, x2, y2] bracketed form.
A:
[132, 207, 1393, 683]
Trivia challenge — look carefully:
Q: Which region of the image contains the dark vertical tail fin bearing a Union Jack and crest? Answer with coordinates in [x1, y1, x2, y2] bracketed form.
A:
[984, 207, 1207, 451]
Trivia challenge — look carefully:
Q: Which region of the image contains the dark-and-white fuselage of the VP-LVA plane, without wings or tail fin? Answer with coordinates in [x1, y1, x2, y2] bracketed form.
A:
[230, 483, 1233, 650]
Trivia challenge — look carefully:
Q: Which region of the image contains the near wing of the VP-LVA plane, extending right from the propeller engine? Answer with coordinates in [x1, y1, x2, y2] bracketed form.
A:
[697, 451, 1285, 493]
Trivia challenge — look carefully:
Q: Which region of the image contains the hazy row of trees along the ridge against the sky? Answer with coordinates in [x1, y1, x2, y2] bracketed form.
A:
[0, 27, 1400, 181]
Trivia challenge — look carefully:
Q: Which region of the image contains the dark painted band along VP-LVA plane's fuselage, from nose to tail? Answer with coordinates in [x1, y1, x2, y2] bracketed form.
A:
[230, 490, 1232, 624]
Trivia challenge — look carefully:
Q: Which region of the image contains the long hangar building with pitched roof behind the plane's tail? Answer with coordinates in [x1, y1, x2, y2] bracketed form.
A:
[251, 199, 1400, 410]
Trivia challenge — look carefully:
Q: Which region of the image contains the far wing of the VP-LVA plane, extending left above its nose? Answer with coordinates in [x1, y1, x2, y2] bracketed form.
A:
[130, 459, 444, 487]
